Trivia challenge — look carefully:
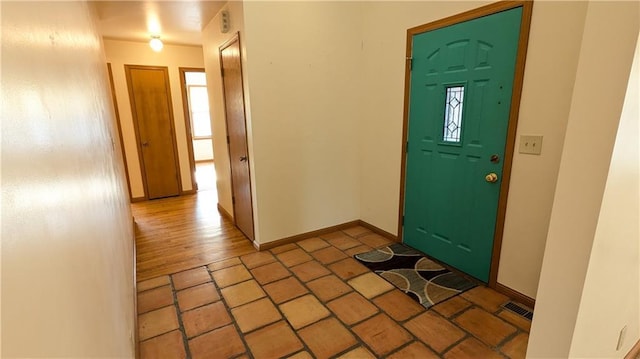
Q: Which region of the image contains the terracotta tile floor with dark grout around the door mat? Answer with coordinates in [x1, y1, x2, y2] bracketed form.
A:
[138, 226, 531, 358]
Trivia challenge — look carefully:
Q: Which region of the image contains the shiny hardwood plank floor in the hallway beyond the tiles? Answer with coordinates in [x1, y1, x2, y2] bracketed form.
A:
[131, 190, 256, 281]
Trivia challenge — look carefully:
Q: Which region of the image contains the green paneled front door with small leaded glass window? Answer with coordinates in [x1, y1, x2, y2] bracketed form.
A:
[403, 7, 522, 282]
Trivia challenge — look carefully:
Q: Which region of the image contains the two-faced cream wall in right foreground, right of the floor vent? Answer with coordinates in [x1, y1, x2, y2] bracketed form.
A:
[527, 1, 640, 358]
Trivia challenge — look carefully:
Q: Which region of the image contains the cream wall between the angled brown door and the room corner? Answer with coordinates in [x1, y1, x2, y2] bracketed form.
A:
[244, 2, 362, 243]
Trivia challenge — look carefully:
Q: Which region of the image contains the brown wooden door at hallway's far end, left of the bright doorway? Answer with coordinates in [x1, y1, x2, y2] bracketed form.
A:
[125, 65, 182, 199]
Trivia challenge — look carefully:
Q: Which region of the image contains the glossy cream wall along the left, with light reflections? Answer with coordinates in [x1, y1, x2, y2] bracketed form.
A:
[0, 2, 135, 358]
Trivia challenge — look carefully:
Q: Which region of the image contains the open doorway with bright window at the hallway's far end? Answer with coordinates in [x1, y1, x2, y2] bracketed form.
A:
[180, 68, 216, 195]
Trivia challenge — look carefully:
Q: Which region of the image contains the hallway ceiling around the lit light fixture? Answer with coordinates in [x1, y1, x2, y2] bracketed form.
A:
[91, 0, 226, 45]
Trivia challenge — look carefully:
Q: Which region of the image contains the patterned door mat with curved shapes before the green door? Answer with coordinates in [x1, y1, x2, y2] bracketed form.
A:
[354, 243, 477, 308]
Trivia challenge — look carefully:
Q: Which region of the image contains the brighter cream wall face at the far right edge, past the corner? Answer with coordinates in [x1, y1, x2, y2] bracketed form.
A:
[570, 31, 640, 358]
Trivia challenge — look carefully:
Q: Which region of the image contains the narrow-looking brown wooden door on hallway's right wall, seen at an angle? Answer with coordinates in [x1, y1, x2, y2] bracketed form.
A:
[220, 35, 253, 240]
